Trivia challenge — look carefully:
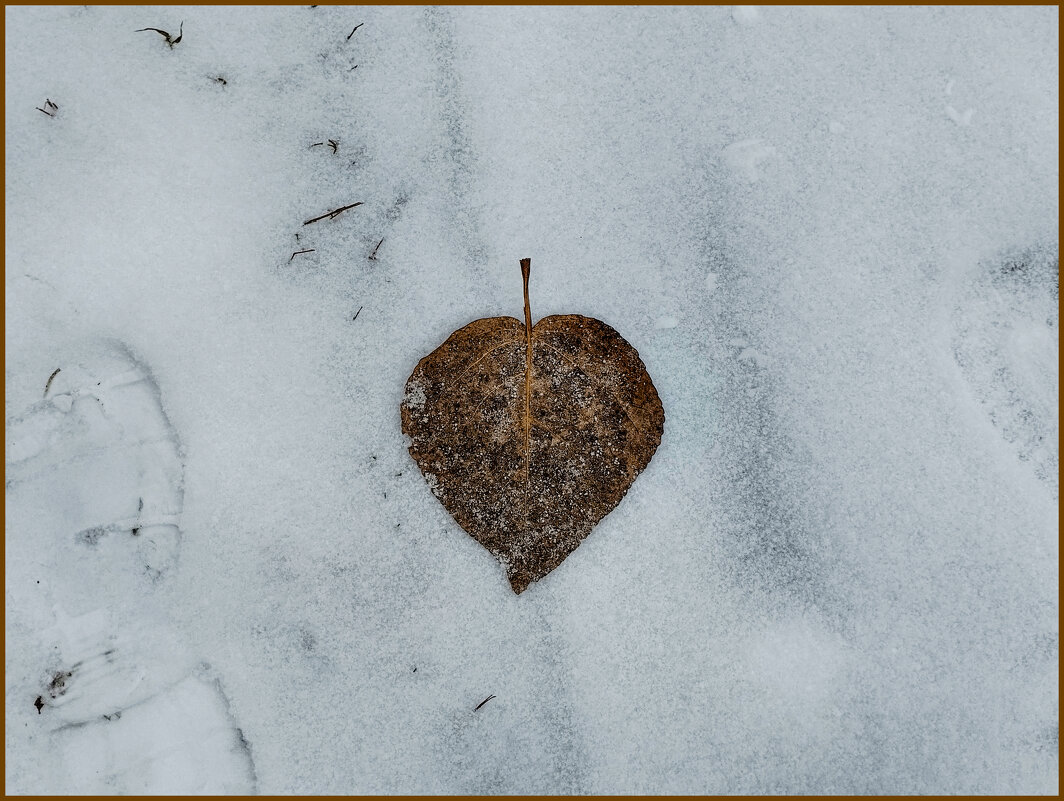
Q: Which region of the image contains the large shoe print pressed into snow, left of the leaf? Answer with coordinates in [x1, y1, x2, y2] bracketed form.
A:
[6, 340, 255, 794]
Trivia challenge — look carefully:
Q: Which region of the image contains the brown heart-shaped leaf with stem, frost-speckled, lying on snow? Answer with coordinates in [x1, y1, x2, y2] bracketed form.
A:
[400, 258, 665, 593]
